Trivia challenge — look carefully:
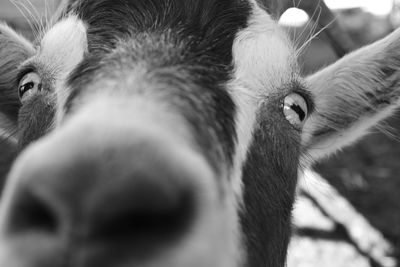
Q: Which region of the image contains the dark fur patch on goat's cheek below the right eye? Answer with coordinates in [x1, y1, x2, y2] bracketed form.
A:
[241, 88, 300, 267]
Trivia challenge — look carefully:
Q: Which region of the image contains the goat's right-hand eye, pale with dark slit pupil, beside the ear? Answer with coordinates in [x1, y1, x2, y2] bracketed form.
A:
[283, 93, 308, 128]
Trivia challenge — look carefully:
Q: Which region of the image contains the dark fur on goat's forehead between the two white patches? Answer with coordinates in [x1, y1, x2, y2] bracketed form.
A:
[66, 0, 250, 170]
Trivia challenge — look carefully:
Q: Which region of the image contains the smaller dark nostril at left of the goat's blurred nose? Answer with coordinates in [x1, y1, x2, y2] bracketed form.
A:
[9, 191, 58, 234]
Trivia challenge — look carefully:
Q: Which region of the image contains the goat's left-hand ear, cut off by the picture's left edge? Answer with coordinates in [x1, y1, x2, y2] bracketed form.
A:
[0, 23, 35, 141]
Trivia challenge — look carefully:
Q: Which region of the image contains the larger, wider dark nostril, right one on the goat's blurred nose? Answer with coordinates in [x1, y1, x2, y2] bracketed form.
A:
[88, 184, 193, 246]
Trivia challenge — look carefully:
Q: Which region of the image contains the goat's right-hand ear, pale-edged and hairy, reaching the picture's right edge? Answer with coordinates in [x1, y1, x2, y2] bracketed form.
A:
[302, 30, 400, 162]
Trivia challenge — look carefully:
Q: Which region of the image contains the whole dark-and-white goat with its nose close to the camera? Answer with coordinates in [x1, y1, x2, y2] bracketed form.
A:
[0, 0, 400, 267]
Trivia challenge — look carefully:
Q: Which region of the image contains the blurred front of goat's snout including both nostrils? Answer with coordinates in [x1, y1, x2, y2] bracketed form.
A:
[0, 123, 216, 266]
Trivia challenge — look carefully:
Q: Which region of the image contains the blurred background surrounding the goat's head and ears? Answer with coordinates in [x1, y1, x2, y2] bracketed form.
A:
[0, 0, 400, 267]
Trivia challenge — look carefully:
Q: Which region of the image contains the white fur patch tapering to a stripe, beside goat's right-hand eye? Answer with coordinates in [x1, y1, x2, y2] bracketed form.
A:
[229, 3, 296, 204]
